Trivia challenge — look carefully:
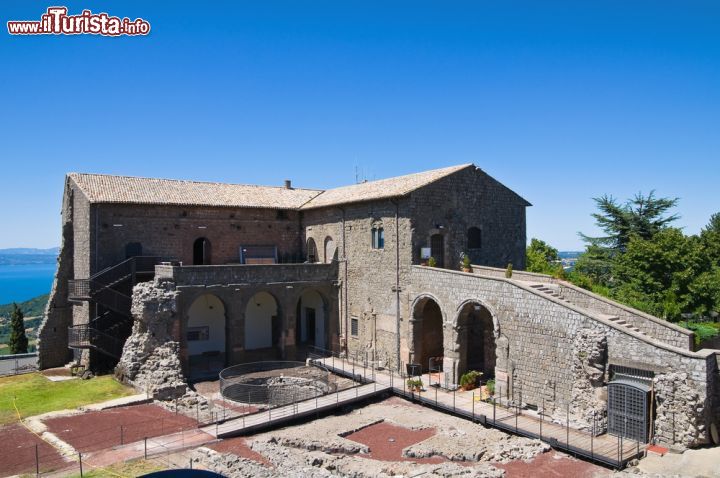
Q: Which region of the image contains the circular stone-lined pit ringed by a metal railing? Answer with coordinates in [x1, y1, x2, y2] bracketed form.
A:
[220, 361, 335, 407]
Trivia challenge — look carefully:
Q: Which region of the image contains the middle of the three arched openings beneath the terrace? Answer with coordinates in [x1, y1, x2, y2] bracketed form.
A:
[245, 291, 281, 350]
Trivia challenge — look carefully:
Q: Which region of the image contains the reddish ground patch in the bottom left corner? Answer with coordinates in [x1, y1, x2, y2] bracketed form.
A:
[0, 424, 69, 476]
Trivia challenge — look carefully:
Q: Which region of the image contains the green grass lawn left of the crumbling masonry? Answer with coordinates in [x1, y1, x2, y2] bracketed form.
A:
[0, 373, 134, 425]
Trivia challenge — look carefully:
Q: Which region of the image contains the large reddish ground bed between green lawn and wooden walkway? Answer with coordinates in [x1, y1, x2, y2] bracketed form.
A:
[44, 404, 197, 453]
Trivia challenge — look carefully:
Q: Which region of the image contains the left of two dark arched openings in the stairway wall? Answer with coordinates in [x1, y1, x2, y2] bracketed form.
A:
[410, 294, 445, 372]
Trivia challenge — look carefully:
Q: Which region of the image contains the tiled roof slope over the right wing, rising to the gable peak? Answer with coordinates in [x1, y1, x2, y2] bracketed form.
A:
[302, 164, 475, 209]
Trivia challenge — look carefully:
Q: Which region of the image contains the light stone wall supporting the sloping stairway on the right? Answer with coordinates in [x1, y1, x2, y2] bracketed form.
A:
[410, 266, 718, 446]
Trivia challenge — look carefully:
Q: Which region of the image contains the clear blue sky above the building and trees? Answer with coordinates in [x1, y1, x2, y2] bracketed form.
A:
[0, 0, 720, 250]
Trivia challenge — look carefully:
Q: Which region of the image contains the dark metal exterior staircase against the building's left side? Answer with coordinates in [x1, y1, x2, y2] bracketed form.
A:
[68, 256, 160, 360]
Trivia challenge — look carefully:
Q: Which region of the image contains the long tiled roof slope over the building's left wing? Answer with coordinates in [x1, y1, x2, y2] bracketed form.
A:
[69, 173, 322, 209]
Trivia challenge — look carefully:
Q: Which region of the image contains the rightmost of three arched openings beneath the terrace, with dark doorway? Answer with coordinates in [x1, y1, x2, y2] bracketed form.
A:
[295, 287, 330, 349]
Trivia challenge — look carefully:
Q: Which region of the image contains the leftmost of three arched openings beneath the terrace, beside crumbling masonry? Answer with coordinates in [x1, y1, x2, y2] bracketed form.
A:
[184, 294, 227, 378]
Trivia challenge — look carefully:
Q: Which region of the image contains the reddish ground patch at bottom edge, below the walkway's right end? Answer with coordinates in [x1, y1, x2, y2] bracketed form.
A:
[492, 451, 608, 478]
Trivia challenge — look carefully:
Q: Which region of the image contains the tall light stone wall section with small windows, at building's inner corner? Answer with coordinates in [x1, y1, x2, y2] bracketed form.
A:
[303, 199, 412, 368]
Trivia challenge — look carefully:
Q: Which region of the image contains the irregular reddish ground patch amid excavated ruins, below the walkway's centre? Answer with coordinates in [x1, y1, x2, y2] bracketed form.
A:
[345, 422, 447, 464]
